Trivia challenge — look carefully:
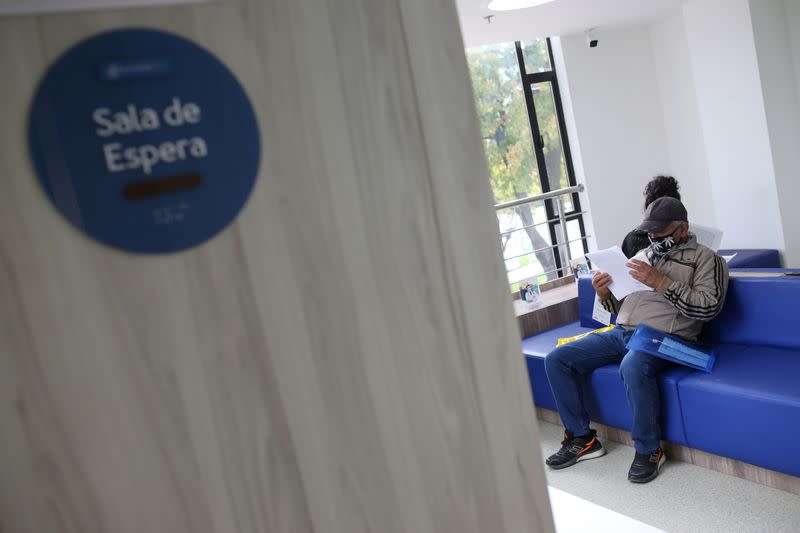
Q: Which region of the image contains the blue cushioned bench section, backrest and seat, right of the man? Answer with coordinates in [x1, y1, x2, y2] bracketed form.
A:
[678, 277, 800, 475]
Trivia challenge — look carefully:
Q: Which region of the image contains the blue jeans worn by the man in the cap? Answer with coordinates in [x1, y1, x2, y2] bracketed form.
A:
[544, 326, 673, 453]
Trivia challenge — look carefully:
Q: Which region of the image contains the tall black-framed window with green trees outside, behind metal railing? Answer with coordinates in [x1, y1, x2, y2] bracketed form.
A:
[467, 39, 588, 290]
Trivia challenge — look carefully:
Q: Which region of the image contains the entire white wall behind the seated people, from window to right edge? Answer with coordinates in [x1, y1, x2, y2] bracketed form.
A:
[555, 0, 800, 260]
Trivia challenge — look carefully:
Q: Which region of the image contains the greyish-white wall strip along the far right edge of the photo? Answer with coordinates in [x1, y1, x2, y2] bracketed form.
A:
[750, 0, 800, 266]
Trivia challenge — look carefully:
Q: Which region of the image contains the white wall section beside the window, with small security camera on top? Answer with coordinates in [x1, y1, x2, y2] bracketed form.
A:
[561, 27, 669, 248]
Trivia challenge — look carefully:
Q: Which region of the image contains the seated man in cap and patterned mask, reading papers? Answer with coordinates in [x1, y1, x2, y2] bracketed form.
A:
[545, 197, 728, 483]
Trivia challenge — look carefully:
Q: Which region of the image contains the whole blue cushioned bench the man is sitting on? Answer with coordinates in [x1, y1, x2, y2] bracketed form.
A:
[522, 277, 800, 476]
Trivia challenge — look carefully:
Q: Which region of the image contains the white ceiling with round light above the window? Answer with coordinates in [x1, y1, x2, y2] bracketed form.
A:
[456, 0, 684, 47]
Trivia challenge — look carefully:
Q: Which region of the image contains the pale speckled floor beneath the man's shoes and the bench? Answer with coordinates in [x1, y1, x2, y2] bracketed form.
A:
[539, 421, 800, 533]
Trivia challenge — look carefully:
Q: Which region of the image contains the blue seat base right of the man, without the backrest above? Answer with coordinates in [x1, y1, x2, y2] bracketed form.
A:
[679, 345, 800, 476]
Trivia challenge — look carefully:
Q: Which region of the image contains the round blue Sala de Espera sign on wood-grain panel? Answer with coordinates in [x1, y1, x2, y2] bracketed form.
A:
[28, 29, 261, 253]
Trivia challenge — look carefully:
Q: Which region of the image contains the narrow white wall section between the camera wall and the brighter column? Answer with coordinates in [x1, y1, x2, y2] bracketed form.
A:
[650, 10, 716, 226]
